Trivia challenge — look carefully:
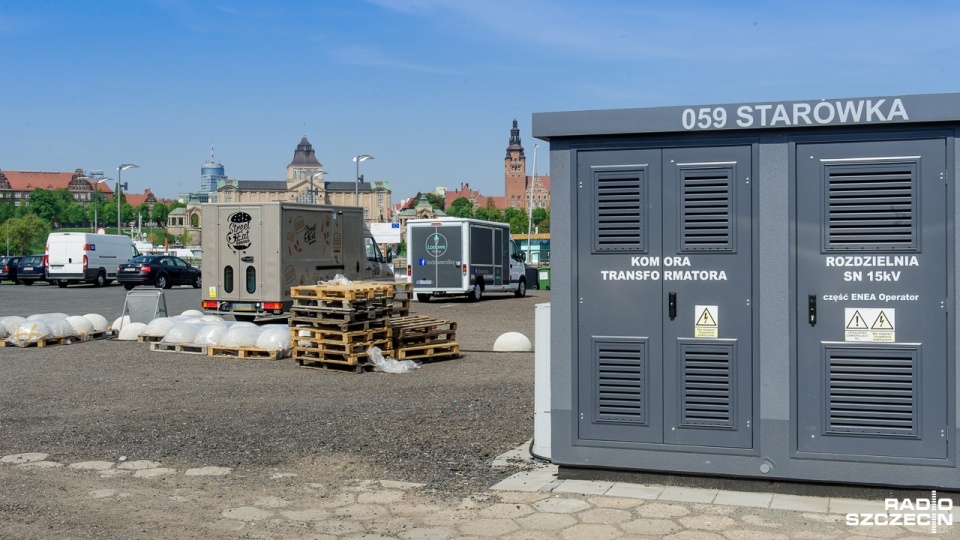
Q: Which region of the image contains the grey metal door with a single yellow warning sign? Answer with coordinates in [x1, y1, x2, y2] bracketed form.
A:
[661, 146, 754, 448]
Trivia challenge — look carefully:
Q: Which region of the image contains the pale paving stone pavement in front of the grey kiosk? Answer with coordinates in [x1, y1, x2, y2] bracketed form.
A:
[0, 447, 960, 540]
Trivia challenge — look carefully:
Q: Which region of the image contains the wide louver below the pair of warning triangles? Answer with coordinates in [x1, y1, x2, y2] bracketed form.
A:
[827, 349, 919, 437]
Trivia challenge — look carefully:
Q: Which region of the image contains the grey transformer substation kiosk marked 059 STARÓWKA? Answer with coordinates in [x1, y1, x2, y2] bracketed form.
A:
[533, 94, 960, 490]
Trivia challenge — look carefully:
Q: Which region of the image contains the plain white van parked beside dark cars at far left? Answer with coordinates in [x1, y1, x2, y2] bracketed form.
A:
[45, 232, 140, 287]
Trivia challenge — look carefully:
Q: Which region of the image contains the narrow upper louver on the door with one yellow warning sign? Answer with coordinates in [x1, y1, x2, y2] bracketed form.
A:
[681, 169, 734, 251]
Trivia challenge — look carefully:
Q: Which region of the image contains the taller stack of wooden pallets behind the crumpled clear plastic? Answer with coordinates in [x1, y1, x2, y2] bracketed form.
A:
[290, 281, 395, 371]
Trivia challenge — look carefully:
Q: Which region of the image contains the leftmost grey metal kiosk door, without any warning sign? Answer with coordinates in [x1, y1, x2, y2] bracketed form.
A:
[574, 150, 663, 442]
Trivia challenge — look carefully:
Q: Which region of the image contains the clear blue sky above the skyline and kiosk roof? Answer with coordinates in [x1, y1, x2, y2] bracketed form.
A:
[0, 0, 960, 201]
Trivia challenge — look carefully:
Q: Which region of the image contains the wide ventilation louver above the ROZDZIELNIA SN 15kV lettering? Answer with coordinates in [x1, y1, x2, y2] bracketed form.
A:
[826, 163, 917, 251]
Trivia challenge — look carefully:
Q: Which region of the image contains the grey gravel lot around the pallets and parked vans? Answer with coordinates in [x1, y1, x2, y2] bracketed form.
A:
[0, 283, 549, 498]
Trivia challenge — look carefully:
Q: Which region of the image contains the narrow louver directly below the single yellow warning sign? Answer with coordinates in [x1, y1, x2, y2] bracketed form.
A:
[681, 346, 734, 428]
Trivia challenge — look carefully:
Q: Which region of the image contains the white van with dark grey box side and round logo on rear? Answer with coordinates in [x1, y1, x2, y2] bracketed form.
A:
[407, 217, 536, 302]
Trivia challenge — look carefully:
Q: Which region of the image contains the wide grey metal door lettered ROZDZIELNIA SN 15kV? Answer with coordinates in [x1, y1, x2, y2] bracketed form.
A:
[795, 138, 955, 459]
